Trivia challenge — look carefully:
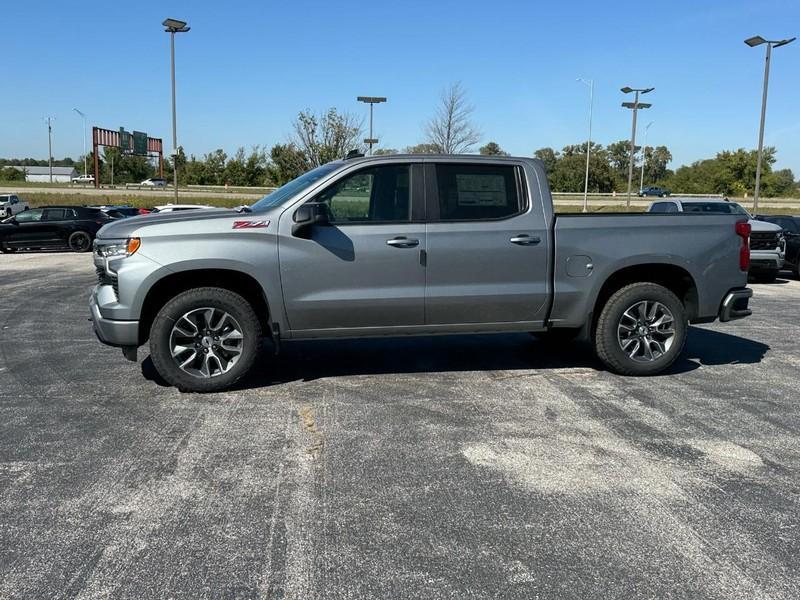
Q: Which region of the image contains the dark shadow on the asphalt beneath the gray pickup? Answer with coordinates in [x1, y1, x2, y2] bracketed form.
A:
[142, 327, 769, 390]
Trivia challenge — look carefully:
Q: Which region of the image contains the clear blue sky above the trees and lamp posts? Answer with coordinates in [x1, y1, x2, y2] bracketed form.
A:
[0, 0, 800, 175]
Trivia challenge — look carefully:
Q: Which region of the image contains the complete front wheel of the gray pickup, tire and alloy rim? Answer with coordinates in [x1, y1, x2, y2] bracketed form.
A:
[150, 287, 261, 392]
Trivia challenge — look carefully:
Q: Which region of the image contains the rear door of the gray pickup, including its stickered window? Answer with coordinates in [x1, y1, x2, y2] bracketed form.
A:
[425, 161, 549, 325]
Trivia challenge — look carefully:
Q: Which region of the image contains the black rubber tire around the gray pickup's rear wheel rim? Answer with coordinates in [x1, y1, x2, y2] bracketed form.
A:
[594, 282, 689, 376]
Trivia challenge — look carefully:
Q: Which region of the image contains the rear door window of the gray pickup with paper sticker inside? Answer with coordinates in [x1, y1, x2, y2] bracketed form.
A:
[436, 163, 523, 221]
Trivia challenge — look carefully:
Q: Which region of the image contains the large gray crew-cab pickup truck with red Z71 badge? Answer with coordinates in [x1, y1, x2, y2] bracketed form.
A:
[90, 155, 752, 392]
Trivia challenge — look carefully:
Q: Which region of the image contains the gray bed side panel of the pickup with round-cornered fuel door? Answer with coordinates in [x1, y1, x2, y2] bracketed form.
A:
[550, 213, 747, 327]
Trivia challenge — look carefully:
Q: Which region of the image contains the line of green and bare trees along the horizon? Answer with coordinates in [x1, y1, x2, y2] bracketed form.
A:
[0, 83, 800, 196]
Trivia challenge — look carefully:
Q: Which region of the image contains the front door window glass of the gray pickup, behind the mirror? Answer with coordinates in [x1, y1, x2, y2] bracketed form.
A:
[313, 165, 411, 224]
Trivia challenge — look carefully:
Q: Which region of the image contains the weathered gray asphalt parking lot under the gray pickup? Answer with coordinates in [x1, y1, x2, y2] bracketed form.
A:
[0, 253, 800, 599]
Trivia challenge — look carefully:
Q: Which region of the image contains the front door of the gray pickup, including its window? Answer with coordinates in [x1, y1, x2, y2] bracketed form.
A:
[279, 163, 426, 337]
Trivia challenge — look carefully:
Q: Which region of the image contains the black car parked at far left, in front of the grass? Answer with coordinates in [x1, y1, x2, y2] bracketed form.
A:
[0, 206, 111, 252]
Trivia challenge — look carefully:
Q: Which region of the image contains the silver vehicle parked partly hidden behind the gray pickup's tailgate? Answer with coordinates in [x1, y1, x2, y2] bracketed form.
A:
[647, 198, 786, 283]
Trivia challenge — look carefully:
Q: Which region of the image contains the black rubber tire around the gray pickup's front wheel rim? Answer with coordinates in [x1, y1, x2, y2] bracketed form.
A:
[150, 287, 261, 392]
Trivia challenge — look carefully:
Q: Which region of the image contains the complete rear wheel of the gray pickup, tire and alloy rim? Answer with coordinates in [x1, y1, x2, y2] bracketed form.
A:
[595, 283, 689, 375]
